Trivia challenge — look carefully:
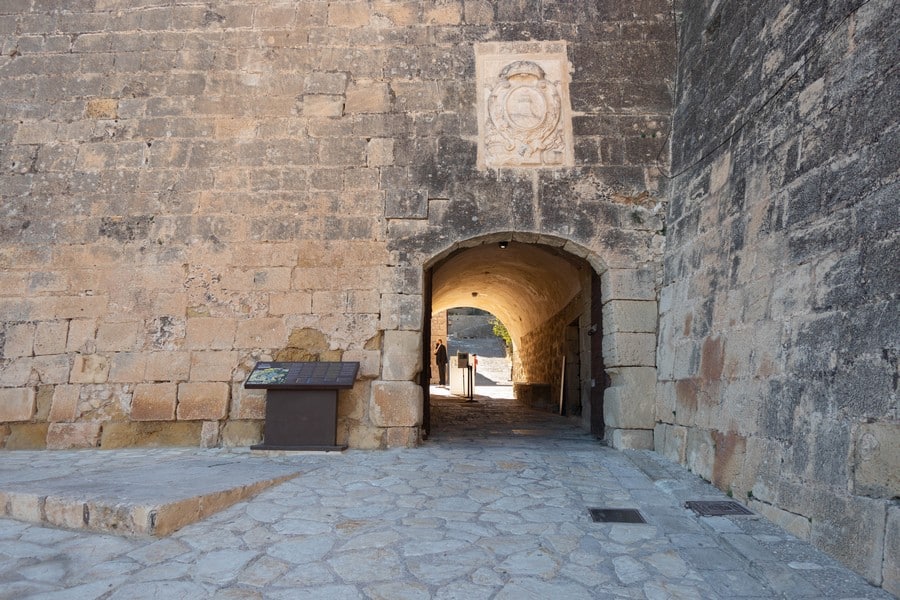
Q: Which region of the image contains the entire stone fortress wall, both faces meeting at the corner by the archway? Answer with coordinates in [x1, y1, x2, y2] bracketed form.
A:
[0, 0, 900, 593]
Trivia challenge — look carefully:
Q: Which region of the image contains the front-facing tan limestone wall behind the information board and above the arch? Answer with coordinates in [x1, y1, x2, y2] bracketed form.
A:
[0, 0, 674, 448]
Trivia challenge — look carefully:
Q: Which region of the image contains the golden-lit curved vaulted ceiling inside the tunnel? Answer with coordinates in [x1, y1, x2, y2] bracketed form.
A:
[432, 242, 586, 343]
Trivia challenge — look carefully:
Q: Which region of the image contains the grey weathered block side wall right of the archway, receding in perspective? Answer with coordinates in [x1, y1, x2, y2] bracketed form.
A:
[656, 0, 900, 593]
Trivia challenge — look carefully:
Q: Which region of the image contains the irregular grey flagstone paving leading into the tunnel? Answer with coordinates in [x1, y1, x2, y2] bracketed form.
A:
[0, 395, 891, 600]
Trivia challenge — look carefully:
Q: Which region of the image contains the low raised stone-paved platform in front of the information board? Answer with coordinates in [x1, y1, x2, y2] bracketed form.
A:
[0, 449, 300, 537]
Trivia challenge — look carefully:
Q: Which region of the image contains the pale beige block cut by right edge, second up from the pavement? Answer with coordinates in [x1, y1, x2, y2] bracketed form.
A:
[853, 422, 900, 498]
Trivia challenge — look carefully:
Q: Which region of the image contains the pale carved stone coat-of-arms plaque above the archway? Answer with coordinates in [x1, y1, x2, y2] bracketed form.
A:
[475, 42, 574, 169]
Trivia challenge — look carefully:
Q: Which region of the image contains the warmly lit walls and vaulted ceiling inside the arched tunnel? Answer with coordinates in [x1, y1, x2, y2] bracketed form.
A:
[422, 236, 608, 437]
